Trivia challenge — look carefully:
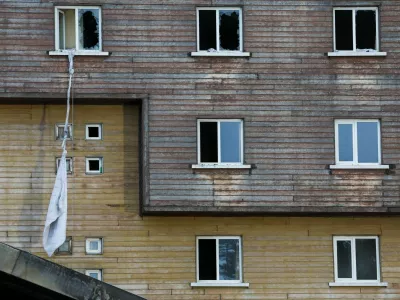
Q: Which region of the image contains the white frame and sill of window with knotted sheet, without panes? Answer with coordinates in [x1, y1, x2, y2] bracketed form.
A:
[53, 5, 109, 56]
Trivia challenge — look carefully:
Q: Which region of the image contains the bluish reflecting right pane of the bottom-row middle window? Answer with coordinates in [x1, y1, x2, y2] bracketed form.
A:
[219, 239, 240, 280]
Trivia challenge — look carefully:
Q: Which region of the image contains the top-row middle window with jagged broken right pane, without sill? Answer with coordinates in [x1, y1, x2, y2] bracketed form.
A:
[197, 8, 243, 52]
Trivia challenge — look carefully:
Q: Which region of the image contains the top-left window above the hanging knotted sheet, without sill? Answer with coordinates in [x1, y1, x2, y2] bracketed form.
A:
[56, 7, 101, 51]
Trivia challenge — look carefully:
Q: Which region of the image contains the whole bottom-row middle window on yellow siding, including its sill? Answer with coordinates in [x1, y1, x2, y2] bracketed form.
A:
[192, 236, 247, 286]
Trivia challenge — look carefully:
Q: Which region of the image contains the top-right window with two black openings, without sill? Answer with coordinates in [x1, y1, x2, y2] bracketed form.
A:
[334, 7, 378, 52]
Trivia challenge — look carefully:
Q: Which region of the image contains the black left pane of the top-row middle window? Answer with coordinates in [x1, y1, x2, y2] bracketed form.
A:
[199, 10, 217, 51]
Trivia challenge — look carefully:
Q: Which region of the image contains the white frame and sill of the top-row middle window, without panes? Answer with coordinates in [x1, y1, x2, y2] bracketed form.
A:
[191, 6, 250, 56]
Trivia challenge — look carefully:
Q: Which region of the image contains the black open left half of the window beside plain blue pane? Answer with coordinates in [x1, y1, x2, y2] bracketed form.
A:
[200, 122, 218, 163]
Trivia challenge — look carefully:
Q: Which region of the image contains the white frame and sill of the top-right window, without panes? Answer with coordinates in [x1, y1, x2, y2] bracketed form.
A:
[328, 6, 387, 56]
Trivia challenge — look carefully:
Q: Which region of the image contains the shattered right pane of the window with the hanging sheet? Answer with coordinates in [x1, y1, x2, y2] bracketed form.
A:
[78, 9, 100, 50]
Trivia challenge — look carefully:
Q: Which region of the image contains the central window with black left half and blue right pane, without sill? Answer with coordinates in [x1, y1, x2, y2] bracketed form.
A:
[198, 120, 243, 164]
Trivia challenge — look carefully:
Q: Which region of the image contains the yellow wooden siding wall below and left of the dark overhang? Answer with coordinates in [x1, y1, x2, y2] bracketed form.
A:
[0, 105, 400, 300]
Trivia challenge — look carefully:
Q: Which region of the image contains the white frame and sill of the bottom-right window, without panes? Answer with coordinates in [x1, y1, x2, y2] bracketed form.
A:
[329, 236, 387, 286]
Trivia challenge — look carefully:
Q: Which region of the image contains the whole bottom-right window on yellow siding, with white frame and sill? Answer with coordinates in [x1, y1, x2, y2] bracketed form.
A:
[330, 236, 384, 285]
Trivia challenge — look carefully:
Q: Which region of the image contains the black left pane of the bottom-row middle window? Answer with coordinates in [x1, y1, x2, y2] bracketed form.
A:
[198, 239, 217, 280]
